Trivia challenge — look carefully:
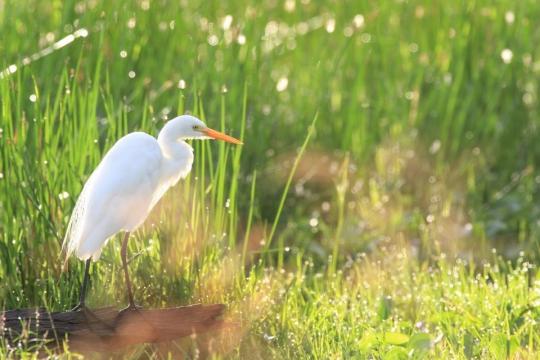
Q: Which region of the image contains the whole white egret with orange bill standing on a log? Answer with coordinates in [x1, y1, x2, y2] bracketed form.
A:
[63, 115, 242, 310]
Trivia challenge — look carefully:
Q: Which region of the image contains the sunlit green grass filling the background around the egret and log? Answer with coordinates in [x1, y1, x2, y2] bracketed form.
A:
[0, 0, 540, 358]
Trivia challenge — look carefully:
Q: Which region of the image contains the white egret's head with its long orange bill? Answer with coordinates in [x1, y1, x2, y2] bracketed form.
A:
[159, 115, 242, 144]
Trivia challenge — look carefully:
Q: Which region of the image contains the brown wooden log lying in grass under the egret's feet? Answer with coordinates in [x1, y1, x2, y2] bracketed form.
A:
[0, 304, 225, 352]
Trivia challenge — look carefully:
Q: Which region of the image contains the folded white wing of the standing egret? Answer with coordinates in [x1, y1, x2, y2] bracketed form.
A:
[64, 133, 162, 259]
